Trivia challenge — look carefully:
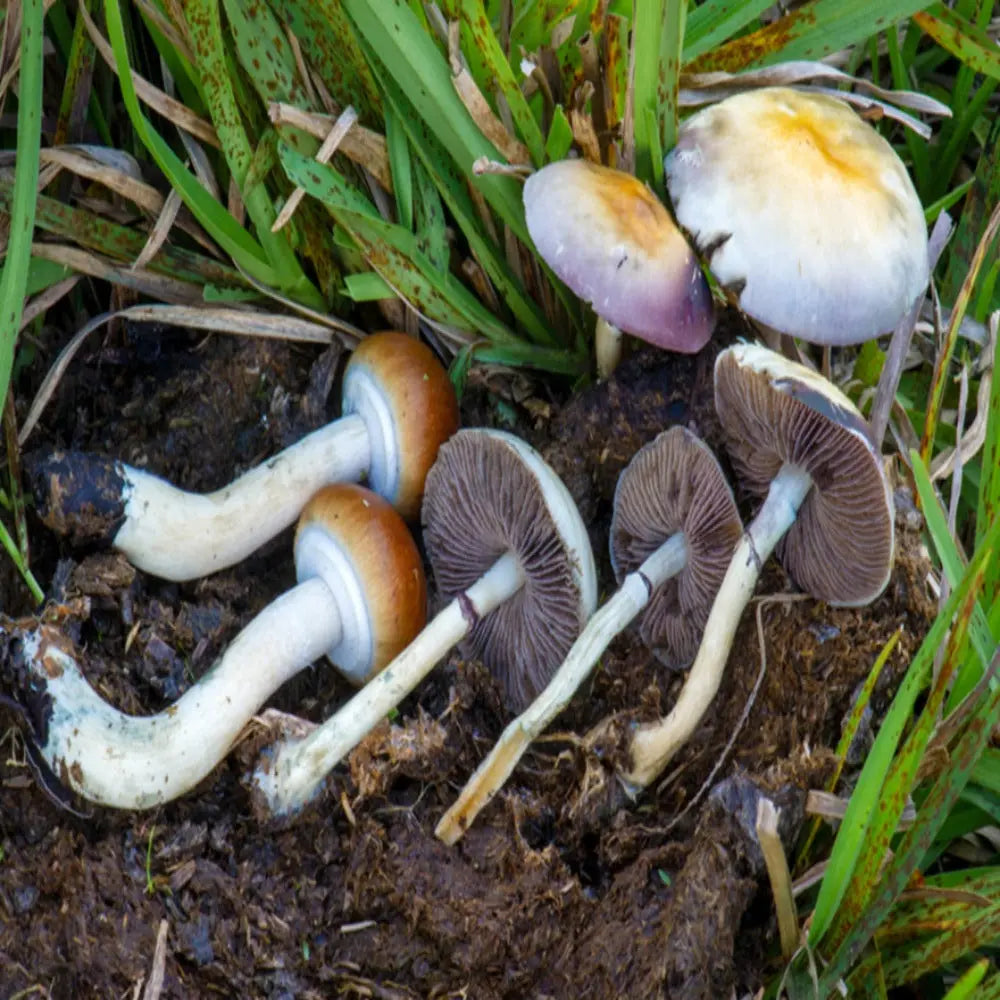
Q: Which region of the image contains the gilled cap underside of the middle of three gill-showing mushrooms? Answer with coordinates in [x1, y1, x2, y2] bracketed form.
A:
[611, 427, 743, 667]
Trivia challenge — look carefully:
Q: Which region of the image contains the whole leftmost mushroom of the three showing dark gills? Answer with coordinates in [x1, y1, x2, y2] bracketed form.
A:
[251, 429, 597, 816]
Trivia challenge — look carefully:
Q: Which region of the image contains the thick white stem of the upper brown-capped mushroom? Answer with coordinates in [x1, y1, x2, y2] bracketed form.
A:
[113, 414, 371, 580]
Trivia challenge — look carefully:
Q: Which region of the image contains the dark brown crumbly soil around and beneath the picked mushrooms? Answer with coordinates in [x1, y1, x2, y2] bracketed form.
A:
[0, 316, 934, 1000]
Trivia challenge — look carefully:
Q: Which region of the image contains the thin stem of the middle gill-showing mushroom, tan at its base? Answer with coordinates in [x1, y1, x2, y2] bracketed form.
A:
[434, 532, 688, 845]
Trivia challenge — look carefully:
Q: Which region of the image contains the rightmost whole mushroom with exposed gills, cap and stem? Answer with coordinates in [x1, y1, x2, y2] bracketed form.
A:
[624, 344, 893, 787]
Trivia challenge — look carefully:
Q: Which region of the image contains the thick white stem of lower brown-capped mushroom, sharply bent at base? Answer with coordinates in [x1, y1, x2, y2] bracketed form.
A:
[25, 579, 341, 809]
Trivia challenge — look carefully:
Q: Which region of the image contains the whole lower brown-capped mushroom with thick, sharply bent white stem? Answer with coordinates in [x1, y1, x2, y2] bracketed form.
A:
[10, 483, 427, 809]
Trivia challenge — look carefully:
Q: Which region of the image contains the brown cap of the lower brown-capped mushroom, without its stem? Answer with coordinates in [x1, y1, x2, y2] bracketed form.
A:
[295, 483, 427, 684]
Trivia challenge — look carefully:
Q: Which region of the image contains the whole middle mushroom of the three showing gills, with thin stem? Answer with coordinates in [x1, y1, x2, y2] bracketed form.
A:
[435, 427, 741, 844]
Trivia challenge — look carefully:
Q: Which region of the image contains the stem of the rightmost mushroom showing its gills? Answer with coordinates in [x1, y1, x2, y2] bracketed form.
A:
[624, 463, 812, 788]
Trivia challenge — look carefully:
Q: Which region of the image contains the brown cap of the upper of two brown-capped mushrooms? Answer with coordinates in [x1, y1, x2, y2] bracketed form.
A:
[343, 330, 458, 520]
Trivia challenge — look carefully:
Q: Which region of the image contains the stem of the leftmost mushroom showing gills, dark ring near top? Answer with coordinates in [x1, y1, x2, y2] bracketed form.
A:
[251, 552, 525, 816]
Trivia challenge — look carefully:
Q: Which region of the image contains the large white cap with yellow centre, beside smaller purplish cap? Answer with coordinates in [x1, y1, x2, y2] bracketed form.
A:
[665, 87, 929, 345]
